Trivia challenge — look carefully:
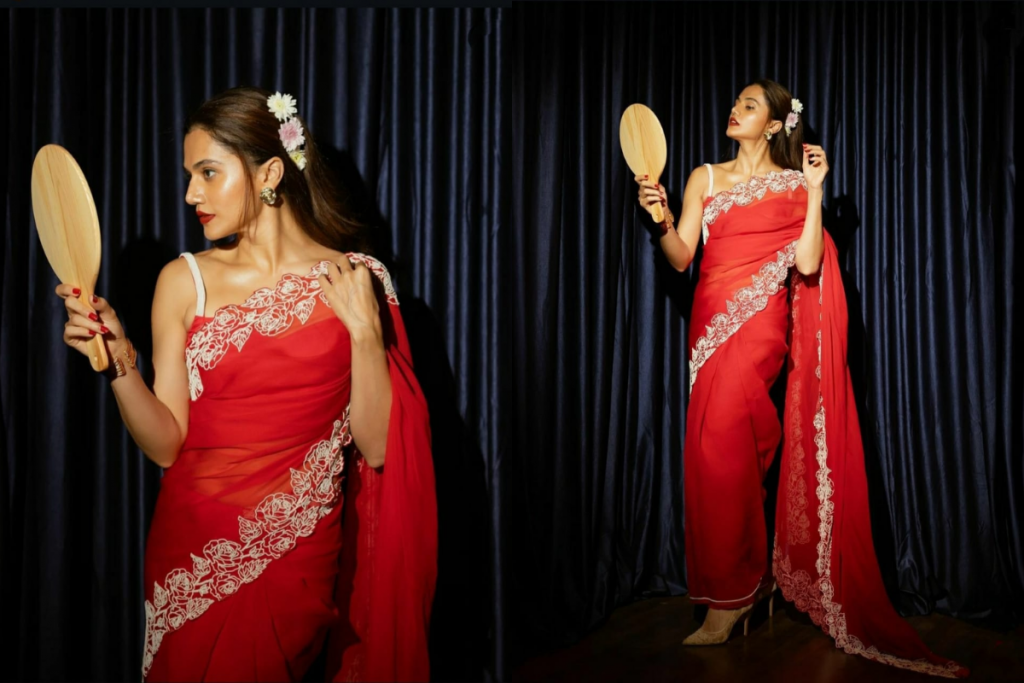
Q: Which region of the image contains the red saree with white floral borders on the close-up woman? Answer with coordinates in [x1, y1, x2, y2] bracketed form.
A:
[142, 254, 437, 681]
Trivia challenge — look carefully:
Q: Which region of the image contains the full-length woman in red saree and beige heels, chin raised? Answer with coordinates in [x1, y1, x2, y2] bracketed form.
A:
[637, 80, 968, 677]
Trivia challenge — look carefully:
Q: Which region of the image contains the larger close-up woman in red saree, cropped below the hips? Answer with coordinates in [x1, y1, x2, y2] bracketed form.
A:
[57, 88, 437, 681]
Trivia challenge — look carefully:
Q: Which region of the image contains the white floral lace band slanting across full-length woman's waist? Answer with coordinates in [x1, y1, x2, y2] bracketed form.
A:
[690, 241, 797, 393]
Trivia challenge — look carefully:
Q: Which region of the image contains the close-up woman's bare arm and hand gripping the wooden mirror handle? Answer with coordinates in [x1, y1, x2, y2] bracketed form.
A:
[57, 260, 193, 467]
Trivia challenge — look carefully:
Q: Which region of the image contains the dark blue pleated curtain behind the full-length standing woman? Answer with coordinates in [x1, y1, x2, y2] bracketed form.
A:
[501, 2, 1024, 671]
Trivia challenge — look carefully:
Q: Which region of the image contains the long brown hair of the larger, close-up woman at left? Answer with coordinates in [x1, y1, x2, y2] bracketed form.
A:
[185, 86, 370, 253]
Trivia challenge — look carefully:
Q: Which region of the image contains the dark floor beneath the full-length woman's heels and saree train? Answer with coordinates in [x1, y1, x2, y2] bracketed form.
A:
[513, 595, 1024, 683]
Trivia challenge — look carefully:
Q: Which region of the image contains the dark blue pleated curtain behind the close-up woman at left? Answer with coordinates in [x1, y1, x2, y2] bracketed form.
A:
[0, 9, 511, 681]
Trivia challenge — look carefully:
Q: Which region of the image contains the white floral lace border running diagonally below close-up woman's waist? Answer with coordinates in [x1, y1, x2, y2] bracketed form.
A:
[142, 409, 352, 678]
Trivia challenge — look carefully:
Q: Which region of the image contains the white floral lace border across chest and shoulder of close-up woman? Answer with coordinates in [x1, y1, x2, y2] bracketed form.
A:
[185, 254, 398, 400]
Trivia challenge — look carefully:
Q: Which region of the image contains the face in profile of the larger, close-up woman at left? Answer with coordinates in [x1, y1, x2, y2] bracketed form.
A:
[184, 129, 253, 242]
